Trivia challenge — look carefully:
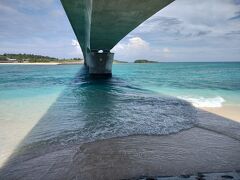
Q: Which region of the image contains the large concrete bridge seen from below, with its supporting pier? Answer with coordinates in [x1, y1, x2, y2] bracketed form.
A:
[61, 0, 174, 76]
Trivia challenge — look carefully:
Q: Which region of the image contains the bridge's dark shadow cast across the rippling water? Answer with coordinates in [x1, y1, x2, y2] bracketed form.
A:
[0, 69, 239, 179]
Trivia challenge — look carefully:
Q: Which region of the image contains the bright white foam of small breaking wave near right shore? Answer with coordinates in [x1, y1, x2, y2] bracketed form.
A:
[178, 96, 225, 108]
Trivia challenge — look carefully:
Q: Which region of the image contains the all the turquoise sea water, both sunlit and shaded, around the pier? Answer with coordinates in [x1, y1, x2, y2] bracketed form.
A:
[0, 63, 240, 165]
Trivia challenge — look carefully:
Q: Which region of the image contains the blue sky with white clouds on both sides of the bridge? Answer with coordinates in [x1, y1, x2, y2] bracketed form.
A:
[0, 0, 240, 62]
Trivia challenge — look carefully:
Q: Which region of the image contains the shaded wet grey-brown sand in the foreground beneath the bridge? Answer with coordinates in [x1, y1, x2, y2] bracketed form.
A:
[0, 111, 240, 180]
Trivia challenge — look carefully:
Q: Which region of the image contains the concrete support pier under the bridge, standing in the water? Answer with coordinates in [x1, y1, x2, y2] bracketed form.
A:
[86, 52, 114, 77]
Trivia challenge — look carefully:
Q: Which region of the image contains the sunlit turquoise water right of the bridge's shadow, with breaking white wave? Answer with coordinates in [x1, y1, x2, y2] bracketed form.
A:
[114, 62, 240, 107]
